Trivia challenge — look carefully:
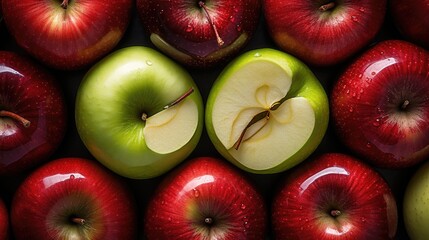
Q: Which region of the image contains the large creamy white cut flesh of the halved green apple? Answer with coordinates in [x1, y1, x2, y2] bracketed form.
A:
[212, 60, 315, 170]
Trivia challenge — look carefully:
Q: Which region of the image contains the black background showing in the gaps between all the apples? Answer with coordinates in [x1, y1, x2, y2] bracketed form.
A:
[0, 3, 418, 239]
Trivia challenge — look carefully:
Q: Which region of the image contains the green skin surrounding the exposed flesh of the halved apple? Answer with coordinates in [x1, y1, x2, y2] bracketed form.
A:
[205, 48, 329, 174]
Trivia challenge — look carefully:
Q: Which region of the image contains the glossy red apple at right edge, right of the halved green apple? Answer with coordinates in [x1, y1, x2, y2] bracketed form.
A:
[331, 40, 429, 168]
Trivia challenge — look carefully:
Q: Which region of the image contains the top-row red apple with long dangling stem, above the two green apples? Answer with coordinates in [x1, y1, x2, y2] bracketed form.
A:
[137, 0, 261, 68]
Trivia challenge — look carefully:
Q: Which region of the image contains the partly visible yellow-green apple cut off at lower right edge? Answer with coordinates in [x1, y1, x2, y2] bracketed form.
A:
[402, 162, 429, 240]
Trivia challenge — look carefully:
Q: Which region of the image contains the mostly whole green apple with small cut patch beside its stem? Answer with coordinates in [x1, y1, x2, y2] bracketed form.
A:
[75, 46, 204, 179]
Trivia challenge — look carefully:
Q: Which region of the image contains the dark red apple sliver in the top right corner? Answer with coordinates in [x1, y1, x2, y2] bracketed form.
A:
[389, 0, 429, 49]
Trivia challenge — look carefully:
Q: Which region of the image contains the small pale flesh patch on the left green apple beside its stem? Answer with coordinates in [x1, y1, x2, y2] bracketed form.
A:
[143, 99, 198, 154]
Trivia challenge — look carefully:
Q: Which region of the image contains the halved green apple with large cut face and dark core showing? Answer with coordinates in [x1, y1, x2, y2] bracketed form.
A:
[206, 48, 329, 173]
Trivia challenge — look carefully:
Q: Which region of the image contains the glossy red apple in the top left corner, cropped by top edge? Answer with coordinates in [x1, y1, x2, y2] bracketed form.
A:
[2, 0, 133, 70]
